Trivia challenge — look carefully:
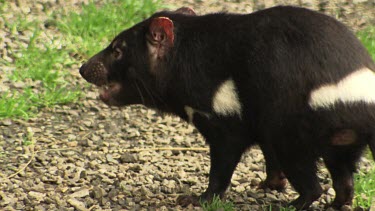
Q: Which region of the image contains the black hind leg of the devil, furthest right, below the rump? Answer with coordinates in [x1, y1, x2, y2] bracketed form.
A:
[323, 145, 363, 209]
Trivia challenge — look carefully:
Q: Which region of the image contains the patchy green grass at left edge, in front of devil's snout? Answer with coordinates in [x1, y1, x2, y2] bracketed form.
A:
[0, 15, 80, 119]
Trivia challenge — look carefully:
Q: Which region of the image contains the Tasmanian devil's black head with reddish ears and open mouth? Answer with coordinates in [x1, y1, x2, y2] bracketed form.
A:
[80, 8, 195, 106]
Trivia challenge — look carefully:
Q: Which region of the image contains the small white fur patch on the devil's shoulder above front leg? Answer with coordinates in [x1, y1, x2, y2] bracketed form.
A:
[212, 79, 242, 117]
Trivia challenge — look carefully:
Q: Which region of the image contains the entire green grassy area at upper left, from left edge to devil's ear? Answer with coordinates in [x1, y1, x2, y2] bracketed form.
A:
[0, 0, 160, 119]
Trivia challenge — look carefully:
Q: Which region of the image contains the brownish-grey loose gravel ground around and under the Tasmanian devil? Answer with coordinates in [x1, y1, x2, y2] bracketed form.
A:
[0, 0, 375, 210]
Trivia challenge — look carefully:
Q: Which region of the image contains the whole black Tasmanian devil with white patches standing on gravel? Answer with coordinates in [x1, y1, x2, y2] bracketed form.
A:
[80, 6, 375, 208]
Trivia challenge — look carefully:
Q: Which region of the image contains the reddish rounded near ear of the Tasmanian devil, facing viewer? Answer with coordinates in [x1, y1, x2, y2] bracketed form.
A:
[149, 17, 174, 46]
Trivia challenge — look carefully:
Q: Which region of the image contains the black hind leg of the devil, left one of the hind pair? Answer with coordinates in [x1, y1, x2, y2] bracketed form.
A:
[273, 118, 323, 209]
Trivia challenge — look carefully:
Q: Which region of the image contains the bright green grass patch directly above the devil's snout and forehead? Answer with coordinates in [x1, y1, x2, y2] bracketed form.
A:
[57, 0, 160, 57]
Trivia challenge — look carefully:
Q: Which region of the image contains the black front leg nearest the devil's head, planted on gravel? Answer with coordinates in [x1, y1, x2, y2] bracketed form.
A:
[177, 115, 252, 206]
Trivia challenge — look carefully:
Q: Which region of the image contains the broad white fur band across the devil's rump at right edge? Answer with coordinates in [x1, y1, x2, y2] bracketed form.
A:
[309, 68, 375, 109]
